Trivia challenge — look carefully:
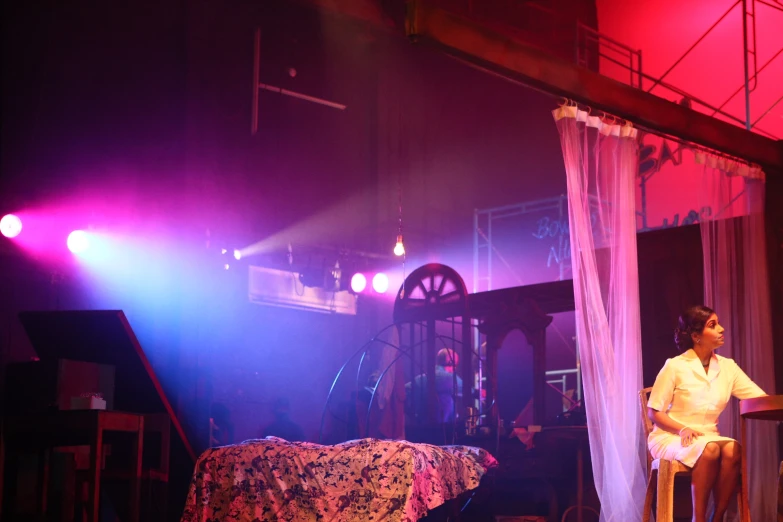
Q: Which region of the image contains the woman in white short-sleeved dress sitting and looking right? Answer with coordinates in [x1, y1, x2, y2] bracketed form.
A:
[647, 306, 766, 522]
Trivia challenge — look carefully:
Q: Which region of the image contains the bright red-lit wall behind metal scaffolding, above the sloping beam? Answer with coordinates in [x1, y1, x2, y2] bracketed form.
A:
[596, 0, 783, 138]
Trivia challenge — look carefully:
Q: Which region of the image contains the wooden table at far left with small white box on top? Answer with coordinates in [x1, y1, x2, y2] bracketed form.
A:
[0, 410, 144, 522]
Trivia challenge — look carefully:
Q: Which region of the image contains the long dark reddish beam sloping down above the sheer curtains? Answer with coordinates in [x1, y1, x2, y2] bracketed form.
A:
[406, 0, 783, 174]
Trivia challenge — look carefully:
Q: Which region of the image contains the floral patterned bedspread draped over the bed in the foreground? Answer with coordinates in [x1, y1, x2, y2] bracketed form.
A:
[182, 437, 497, 522]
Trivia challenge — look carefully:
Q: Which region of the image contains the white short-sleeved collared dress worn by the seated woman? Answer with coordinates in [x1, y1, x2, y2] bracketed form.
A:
[647, 349, 766, 467]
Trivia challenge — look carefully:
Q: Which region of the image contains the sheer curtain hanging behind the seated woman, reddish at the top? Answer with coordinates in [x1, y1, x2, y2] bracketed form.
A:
[696, 153, 777, 521]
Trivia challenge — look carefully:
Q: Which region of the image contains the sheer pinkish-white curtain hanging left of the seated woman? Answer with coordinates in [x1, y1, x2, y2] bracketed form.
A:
[553, 106, 646, 522]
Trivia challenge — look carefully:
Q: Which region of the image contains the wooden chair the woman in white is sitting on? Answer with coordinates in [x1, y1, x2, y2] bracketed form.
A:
[639, 388, 750, 522]
